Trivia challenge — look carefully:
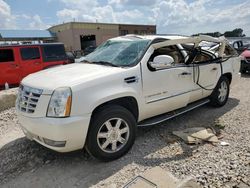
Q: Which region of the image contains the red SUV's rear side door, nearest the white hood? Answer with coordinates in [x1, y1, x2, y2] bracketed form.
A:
[19, 46, 42, 77]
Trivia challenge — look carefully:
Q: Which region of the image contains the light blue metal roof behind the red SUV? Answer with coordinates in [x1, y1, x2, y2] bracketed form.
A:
[0, 30, 55, 39]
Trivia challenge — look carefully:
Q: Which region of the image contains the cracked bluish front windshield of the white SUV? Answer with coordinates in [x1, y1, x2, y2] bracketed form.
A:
[83, 39, 150, 67]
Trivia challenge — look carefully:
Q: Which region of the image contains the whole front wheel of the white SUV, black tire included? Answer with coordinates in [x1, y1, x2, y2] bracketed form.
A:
[86, 105, 137, 161]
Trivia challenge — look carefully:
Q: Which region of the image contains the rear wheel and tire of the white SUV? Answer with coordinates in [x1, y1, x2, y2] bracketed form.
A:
[210, 76, 230, 107]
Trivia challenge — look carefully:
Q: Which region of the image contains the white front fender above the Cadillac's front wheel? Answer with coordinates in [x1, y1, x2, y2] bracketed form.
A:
[71, 75, 141, 116]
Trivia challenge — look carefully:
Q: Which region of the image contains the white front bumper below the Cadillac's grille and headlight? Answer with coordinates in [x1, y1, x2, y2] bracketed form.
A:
[18, 114, 90, 152]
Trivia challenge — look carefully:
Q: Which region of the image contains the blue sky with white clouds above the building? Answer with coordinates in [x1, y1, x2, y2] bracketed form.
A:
[0, 0, 250, 36]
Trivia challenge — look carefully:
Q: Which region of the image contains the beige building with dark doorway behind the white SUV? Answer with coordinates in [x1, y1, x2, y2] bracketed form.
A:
[49, 22, 156, 51]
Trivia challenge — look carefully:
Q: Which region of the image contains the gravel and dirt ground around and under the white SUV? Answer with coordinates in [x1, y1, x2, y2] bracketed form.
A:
[0, 75, 250, 188]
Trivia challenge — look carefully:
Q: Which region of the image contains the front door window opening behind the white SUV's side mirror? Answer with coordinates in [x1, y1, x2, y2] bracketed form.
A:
[149, 46, 185, 64]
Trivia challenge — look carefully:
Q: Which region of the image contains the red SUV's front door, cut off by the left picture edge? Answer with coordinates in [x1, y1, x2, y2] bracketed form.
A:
[0, 48, 21, 87]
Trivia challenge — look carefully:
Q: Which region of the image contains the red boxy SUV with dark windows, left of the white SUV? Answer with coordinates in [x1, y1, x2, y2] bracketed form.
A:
[0, 43, 69, 90]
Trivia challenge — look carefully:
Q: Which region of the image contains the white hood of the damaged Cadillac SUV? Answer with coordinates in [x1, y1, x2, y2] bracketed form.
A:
[22, 63, 123, 94]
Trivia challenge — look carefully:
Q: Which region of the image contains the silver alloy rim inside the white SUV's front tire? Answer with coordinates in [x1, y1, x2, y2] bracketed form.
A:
[97, 118, 129, 153]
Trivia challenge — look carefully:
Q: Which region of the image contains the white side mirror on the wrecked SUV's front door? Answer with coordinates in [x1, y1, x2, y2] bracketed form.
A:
[149, 55, 174, 69]
